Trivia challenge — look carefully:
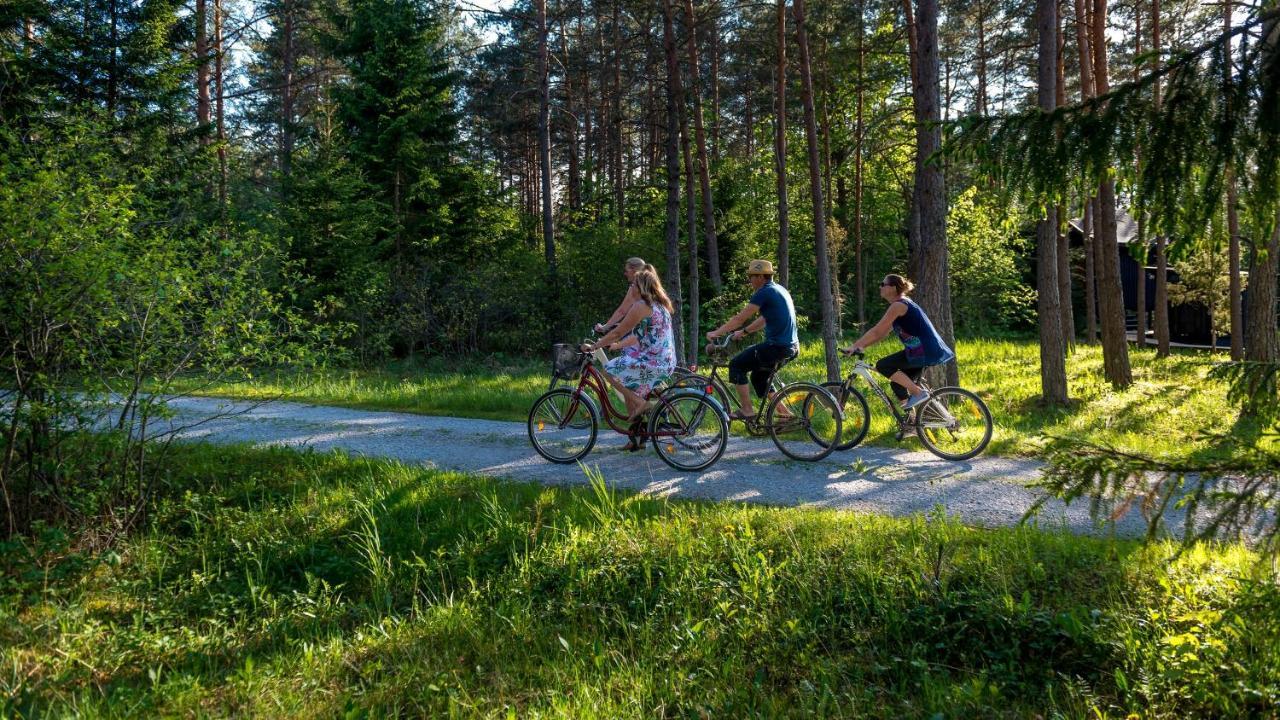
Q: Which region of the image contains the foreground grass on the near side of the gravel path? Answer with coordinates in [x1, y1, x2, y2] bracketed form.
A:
[0, 446, 1280, 719]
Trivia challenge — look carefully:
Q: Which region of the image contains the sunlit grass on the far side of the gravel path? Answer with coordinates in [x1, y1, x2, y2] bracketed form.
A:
[167, 340, 1260, 457]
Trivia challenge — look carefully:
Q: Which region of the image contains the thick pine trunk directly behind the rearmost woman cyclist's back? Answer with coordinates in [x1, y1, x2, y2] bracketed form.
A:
[911, 0, 959, 386]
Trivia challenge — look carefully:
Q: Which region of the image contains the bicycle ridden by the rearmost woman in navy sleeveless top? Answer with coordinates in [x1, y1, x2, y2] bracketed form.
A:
[823, 350, 992, 460]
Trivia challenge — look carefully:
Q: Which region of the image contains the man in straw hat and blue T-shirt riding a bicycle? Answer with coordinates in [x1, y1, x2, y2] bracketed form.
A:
[707, 260, 800, 420]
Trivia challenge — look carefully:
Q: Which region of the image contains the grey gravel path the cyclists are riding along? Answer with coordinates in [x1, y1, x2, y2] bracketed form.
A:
[154, 397, 1144, 534]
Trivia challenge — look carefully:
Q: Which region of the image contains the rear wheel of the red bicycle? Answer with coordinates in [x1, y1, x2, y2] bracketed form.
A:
[649, 392, 728, 471]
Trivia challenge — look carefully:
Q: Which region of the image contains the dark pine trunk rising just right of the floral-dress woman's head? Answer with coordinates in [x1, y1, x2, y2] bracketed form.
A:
[662, 0, 698, 365]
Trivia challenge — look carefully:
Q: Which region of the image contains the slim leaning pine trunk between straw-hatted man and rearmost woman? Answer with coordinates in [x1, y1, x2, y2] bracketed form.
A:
[793, 0, 844, 380]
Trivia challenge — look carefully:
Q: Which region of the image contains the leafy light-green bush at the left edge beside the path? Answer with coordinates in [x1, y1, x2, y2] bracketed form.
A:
[0, 123, 304, 536]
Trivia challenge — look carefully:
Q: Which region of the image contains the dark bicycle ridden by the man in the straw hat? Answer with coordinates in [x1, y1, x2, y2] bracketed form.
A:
[672, 333, 842, 461]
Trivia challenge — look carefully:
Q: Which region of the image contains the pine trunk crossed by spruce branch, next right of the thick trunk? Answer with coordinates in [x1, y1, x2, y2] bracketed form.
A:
[1036, 0, 1068, 405]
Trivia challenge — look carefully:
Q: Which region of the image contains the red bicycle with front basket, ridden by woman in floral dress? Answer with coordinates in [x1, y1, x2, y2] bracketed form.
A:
[529, 345, 728, 471]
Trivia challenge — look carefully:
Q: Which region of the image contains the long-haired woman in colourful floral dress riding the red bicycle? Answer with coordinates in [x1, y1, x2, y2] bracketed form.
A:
[582, 269, 676, 450]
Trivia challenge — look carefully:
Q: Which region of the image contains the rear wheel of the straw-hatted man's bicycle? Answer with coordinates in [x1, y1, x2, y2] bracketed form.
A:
[764, 383, 841, 461]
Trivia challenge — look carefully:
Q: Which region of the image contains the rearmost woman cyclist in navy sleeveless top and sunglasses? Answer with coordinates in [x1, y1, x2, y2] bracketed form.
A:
[844, 274, 956, 410]
